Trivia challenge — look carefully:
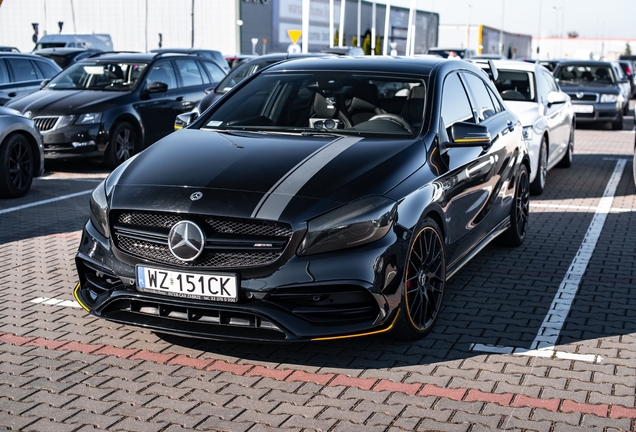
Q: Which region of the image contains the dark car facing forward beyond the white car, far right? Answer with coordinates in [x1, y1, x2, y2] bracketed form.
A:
[554, 60, 629, 130]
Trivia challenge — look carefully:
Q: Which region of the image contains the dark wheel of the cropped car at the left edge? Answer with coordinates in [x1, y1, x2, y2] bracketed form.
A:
[0, 134, 35, 198]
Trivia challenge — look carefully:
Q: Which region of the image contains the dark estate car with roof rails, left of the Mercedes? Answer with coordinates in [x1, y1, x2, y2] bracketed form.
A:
[4, 53, 225, 168]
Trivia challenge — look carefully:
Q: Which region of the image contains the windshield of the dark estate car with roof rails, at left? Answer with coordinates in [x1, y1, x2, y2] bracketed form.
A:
[45, 62, 147, 91]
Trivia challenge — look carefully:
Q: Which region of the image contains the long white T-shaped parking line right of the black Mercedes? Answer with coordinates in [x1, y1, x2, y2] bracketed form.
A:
[470, 159, 627, 363]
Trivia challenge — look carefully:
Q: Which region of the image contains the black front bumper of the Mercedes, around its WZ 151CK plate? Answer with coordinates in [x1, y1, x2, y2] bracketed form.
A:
[74, 221, 408, 342]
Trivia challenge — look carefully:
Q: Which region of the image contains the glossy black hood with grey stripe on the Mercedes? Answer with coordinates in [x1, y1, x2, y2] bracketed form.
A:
[109, 129, 426, 223]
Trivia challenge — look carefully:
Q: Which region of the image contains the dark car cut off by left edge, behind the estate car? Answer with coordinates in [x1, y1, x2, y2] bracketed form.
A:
[0, 52, 62, 105]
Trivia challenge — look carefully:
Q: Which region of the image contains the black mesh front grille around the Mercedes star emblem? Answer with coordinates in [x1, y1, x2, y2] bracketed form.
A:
[110, 211, 292, 268]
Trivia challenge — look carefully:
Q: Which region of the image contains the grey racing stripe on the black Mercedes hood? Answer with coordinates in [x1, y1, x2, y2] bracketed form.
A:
[252, 137, 362, 220]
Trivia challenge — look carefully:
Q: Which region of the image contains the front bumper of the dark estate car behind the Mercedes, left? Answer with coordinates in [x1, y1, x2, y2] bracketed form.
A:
[42, 124, 109, 159]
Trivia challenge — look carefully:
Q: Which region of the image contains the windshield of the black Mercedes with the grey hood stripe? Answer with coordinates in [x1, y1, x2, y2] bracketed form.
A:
[199, 71, 426, 135]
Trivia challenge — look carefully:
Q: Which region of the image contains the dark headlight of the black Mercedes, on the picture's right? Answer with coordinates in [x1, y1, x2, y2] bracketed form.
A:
[298, 196, 397, 255]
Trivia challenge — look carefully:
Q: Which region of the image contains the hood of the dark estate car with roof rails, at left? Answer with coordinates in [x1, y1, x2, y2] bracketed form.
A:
[7, 90, 130, 117]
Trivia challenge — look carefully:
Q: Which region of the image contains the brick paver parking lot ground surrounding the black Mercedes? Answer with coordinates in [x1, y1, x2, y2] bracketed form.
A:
[0, 106, 636, 432]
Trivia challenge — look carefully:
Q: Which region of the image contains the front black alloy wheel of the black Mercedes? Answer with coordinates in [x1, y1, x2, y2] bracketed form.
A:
[394, 218, 446, 340]
